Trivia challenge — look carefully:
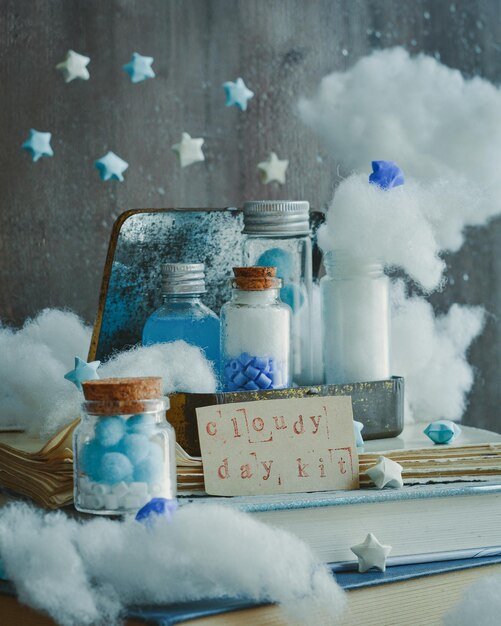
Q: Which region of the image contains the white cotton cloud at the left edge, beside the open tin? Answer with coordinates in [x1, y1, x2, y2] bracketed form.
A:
[0, 309, 91, 433]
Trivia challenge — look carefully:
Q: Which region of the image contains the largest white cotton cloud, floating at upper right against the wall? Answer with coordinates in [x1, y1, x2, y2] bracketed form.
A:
[299, 48, 501, 256]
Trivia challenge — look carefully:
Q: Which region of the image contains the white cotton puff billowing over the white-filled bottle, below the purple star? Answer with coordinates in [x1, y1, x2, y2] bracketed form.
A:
[318, 175, 445, 291]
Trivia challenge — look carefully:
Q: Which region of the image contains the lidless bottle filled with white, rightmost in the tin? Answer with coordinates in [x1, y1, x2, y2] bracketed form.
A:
[320, 251, 390, 384]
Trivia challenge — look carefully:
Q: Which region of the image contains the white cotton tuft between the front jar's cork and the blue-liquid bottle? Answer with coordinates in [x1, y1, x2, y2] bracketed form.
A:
[99, 341, 217, 395]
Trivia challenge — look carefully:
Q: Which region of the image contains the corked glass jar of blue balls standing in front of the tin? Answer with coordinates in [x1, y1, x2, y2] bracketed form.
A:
[73, 378, 176, 515]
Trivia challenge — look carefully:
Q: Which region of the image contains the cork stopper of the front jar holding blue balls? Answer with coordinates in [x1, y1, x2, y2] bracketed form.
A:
[82, 376, 162, 415]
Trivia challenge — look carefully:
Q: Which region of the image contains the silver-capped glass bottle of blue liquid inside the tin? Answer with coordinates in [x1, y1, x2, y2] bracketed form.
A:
[143, 263, 220, 371]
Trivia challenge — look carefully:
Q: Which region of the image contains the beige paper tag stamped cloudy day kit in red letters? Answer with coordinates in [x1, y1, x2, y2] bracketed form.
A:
[196, 396, 359, 496]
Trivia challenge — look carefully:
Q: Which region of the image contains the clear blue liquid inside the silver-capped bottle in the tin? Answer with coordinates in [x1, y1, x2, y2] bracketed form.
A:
[143, 313, 220, 372]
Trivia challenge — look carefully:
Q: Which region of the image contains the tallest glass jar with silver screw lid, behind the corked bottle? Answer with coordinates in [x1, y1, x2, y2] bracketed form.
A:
[243, 200, 312, 385]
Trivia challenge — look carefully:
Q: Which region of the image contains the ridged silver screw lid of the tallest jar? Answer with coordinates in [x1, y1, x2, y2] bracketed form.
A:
[242, 200, 310, 237]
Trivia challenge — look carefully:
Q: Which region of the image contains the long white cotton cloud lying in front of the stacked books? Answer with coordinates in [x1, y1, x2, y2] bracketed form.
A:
[0, 504, 345, 626]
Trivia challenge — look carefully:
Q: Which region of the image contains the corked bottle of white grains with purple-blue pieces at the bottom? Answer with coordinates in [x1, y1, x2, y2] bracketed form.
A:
[221, 267, 291, 391]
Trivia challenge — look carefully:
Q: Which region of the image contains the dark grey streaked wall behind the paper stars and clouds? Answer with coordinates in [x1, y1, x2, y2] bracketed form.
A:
[0, 0, 501, 429]
